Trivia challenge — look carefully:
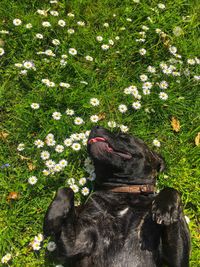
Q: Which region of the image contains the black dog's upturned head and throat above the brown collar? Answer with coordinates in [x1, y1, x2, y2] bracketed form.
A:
[87, 126, 164, 185]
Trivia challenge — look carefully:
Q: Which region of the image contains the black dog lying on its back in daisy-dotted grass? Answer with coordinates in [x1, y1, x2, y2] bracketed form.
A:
[44, 127, 190, 267]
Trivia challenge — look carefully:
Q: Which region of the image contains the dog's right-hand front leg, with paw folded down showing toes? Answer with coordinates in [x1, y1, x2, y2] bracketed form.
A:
[152, 188, 190, 267]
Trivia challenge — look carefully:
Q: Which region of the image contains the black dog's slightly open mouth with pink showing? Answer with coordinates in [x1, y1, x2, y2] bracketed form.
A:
[88, 136, 132, 159]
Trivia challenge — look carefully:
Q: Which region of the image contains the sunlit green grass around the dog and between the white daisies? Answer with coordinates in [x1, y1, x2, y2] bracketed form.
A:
[0, 0, 200, 267]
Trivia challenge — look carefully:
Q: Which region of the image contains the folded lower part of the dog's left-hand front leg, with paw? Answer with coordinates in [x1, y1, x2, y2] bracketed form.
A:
[43, 188, 74, 237]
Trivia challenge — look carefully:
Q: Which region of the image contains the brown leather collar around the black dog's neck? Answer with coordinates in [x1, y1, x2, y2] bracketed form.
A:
[110, 184, 155, 193]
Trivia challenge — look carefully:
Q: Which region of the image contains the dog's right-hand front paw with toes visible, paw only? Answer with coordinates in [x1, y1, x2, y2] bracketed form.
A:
[152, 188, 181, 225]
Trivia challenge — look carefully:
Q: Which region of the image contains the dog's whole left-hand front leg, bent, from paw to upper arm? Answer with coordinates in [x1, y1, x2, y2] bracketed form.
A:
[43, 188, 95, 258]
